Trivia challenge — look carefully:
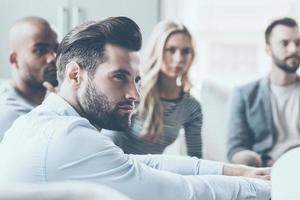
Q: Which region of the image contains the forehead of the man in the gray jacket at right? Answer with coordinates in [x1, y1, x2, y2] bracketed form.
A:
[270, 25, 300, 41]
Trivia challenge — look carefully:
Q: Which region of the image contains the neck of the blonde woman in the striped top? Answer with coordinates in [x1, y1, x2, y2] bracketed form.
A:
[159, 74, 182, 99]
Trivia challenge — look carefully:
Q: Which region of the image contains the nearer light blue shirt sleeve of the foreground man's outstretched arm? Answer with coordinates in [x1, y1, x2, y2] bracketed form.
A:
[45, 123, 270, 200]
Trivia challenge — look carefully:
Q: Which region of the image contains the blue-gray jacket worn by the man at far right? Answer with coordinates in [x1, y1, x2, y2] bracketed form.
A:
[227, 77, 275, 160]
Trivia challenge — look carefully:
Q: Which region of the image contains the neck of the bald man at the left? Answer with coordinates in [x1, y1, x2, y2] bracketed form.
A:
[13, 79, 47, 105]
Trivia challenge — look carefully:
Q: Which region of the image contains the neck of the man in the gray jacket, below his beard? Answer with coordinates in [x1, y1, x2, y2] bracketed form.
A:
[270, 66, 298, 86]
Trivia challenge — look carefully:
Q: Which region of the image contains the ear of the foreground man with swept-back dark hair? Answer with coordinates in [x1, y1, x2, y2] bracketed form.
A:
[65, 61, 82, 86]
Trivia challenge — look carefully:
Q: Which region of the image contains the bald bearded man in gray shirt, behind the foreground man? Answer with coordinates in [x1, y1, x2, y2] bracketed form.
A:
[0, 17, 58, 142]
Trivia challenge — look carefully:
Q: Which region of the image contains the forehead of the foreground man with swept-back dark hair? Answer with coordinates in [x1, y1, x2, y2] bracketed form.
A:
[97, 44, 140, 75]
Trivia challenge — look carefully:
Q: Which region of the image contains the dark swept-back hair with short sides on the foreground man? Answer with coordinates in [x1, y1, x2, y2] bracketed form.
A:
[56, 17, 142, 83]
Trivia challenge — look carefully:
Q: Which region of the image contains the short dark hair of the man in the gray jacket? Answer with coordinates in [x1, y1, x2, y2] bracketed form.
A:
[265, 17, 298, 44]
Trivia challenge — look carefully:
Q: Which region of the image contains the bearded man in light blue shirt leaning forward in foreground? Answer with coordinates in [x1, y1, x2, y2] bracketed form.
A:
[0, 17, 270, 200]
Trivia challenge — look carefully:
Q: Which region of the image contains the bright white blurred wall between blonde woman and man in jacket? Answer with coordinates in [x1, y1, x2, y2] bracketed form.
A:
[162, 0, 300, 85]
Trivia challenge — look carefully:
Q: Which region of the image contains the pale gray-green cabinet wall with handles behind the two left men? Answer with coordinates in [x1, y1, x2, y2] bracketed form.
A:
[0, 0, 160, 78]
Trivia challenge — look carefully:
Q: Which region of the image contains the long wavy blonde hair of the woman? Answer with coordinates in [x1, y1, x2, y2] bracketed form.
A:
[138, 21, 195, 141]
